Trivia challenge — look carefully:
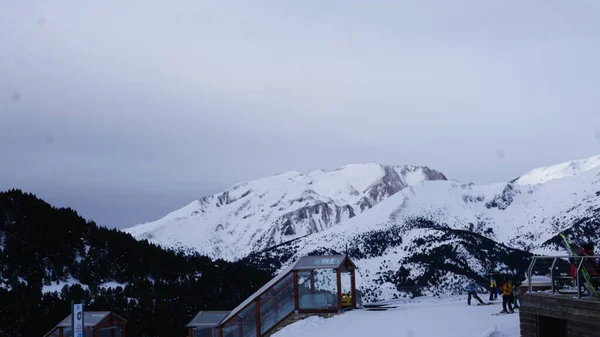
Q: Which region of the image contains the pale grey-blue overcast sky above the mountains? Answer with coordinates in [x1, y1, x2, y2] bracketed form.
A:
[0, 0, 600, 228]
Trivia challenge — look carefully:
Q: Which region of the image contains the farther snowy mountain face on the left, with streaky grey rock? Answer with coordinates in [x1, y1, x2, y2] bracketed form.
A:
[125, 163, 446, 260]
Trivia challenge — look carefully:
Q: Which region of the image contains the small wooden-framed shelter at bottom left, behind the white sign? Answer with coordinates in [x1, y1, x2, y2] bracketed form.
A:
[44, 311, 127, 337]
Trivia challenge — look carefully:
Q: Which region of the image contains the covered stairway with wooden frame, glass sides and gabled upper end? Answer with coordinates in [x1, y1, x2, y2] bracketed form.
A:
[216, 255, 357, 337]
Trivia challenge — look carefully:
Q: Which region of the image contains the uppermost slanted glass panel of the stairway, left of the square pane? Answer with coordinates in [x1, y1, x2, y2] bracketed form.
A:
[260, 273, 294, 333]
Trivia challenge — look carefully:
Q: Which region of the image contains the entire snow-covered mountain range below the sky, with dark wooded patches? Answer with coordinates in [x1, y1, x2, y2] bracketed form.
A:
[123, 156, 600, 299]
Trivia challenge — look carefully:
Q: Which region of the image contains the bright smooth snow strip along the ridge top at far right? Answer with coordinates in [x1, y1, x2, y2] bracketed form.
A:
[515, 155, 600, 185]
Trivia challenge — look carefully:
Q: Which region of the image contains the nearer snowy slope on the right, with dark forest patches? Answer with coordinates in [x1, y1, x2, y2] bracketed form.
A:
[249, 154, 600, 299]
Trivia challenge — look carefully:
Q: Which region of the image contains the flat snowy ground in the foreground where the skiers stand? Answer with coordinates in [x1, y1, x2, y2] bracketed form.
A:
[273, 295, 520, 337]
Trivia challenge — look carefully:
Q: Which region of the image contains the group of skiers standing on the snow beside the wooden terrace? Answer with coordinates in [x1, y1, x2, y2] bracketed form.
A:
[466, 273, 521, 313]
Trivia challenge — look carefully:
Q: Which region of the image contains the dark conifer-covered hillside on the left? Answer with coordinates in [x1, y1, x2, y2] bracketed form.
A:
[0, 190, 270, 337]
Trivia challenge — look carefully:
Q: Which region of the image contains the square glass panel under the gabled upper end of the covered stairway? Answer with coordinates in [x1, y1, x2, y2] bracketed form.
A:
[298, 269, 337, 310]
